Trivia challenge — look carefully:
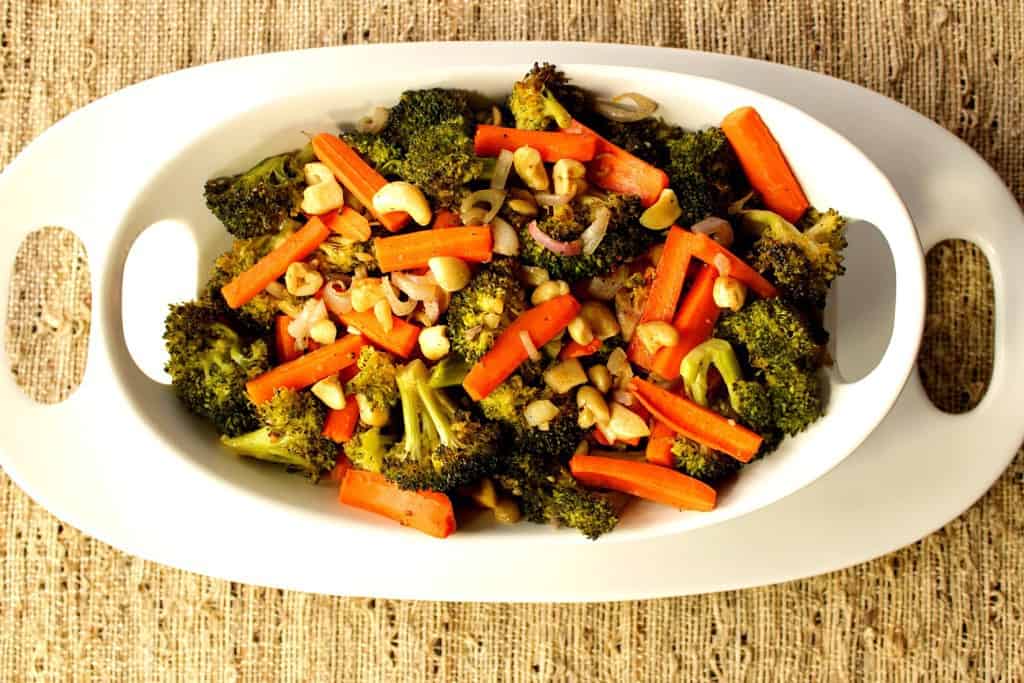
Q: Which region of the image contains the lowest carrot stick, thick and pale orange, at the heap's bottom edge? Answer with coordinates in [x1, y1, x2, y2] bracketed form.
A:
[338, 469, 455, 539]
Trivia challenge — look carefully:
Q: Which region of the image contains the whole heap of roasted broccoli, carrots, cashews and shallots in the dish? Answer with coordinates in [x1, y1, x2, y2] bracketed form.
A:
[165, 65, 846, 538]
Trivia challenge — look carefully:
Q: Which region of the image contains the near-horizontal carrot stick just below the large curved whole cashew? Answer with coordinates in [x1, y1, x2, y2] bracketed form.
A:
[374, 225, 494, 272]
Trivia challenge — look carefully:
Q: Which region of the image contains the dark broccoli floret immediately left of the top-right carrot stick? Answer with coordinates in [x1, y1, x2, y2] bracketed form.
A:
[663, 128, 748, 226]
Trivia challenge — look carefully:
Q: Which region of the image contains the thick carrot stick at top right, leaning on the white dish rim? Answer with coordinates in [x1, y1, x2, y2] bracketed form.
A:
[722, 106, 810, 223]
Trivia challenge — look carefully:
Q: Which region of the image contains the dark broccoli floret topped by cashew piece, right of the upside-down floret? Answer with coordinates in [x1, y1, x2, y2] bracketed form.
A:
[478, 375, 584, 460]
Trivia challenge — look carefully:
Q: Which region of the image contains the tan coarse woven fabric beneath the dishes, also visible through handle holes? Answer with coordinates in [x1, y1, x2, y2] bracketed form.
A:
[0, 0, 1024, 681]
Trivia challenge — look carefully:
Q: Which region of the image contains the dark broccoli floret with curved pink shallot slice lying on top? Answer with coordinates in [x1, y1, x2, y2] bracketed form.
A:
[519, 195, 658, 282]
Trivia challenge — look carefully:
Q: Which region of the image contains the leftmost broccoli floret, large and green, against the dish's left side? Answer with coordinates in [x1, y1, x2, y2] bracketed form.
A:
[164, 300, 269, 435]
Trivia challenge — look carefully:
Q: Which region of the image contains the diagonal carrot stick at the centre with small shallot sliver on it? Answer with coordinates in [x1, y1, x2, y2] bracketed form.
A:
[462, 294, 580, 400]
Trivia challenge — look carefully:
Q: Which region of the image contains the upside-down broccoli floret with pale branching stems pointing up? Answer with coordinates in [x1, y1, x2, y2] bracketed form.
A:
[383, 359, 499, 492]
